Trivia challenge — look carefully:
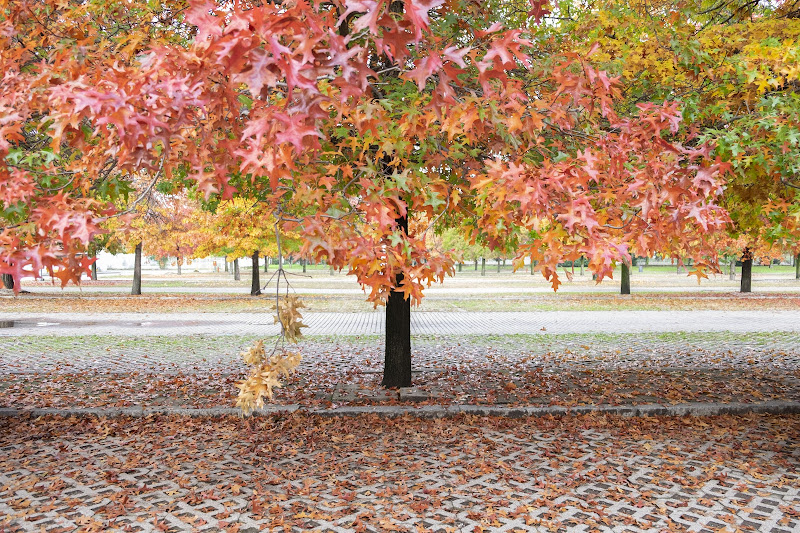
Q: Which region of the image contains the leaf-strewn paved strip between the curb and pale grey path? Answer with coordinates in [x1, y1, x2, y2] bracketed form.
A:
[0, 333, 800, 408]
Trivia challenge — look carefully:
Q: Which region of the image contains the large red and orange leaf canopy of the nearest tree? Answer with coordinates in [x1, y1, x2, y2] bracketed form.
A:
[0, 0, 728, 296]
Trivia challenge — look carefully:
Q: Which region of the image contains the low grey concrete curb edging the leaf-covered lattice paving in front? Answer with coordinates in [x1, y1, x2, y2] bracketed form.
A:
[0, 400, 800, 418]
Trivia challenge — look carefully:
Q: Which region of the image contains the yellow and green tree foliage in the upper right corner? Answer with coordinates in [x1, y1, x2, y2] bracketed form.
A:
[547, 0, 800, 291]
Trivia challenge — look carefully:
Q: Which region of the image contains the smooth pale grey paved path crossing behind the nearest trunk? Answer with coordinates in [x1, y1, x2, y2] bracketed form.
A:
[0, 310, 800, 336]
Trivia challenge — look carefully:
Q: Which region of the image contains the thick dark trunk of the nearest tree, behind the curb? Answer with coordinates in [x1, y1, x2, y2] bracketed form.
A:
[381, 217, 411, 388]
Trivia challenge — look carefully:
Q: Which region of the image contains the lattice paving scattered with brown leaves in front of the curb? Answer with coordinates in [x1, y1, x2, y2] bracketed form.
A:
[0, 415, 800, 533]
